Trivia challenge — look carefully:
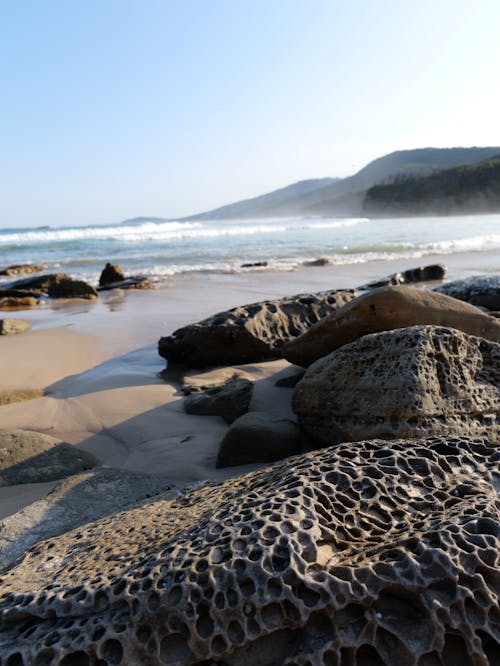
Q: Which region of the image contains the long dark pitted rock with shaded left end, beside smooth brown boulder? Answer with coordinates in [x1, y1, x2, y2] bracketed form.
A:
[158, 290, 354, 367]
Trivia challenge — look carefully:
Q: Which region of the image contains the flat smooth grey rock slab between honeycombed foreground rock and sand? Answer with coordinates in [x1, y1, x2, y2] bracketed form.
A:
[0, 467, 176, 567]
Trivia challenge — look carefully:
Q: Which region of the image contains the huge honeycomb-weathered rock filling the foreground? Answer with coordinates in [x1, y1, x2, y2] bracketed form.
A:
[0, 438, 500, 666]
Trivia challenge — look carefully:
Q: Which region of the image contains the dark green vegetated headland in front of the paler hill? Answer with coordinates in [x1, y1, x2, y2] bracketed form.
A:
[364, 155, 500, 215]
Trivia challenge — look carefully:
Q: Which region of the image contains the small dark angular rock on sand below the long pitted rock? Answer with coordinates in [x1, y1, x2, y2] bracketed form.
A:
[184, 376, 253, 423]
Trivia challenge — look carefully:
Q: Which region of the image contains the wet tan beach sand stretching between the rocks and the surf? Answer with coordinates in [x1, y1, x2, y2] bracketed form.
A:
[0, 252, 500, 518]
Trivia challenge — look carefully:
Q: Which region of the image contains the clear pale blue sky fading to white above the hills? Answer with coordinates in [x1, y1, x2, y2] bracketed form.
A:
[0, 0, 500, 227]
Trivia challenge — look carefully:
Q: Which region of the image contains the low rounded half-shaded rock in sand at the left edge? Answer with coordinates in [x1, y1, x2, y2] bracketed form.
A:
[0, 430, 99, 486]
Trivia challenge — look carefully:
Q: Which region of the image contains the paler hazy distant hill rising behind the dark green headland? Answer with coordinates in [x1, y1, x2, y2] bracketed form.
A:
[185, 146, 500, 220]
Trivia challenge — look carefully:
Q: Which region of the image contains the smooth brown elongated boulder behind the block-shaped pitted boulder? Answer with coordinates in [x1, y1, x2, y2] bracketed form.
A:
[281, 286, 500, 366]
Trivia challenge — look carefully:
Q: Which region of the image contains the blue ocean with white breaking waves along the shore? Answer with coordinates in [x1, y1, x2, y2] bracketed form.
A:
[0, 215, 500, 284]
